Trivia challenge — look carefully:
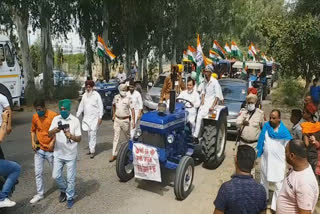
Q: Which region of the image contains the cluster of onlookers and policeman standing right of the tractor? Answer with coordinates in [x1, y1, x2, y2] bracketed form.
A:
[214, 79, 320, 214]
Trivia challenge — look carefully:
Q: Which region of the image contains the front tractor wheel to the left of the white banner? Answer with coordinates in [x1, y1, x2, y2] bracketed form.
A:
[116, 142, 134, 182]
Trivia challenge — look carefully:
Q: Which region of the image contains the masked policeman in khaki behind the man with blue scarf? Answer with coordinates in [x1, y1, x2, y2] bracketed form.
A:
[236, 94, 265, 149]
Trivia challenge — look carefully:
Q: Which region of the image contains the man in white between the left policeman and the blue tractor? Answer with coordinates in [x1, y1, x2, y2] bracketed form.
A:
[127, 81, 143, 138]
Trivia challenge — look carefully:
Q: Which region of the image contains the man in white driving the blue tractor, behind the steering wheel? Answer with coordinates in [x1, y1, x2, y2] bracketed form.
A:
[178, 78, 200, 134]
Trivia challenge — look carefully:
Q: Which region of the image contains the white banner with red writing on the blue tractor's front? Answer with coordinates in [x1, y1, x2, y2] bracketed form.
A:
[132, 143, 161, 182]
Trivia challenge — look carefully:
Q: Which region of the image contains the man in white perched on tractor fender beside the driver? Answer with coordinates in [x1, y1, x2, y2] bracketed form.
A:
[193, 65, 223, 139]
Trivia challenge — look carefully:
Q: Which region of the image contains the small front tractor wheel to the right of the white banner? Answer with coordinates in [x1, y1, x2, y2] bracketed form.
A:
[174, 156, 194, 200]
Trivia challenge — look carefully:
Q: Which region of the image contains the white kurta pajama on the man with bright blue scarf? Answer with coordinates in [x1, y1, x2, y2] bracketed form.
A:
[261, 132, 289, 211]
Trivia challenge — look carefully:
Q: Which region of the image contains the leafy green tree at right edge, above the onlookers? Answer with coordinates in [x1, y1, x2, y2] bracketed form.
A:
[261, 14, 320, 90]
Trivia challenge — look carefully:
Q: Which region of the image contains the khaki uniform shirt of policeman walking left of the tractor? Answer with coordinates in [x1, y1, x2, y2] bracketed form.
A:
[112, 94, 133, 117]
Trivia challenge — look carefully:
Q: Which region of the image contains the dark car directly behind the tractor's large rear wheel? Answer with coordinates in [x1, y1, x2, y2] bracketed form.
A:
[219, 79, 249, 133]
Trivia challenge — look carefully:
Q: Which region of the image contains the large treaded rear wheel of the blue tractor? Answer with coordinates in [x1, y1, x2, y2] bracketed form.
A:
[201, 121, 227, 169]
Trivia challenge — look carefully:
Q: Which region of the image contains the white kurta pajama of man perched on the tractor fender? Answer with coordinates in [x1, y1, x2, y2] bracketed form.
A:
[193, 77, 223, 138]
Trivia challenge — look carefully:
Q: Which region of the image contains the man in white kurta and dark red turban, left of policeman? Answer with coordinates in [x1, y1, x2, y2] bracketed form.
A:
[77, 80, 103, 158]
